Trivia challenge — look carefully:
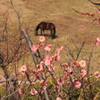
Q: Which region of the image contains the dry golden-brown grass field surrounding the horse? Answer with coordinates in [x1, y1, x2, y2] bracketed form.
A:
[0, 0, 100, 70]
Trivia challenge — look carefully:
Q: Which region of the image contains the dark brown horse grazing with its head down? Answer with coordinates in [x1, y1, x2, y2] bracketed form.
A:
[35, 22, 56, 39]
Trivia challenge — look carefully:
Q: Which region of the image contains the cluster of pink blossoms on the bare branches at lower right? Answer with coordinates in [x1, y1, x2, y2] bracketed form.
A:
[57, 60, 87, 88]
